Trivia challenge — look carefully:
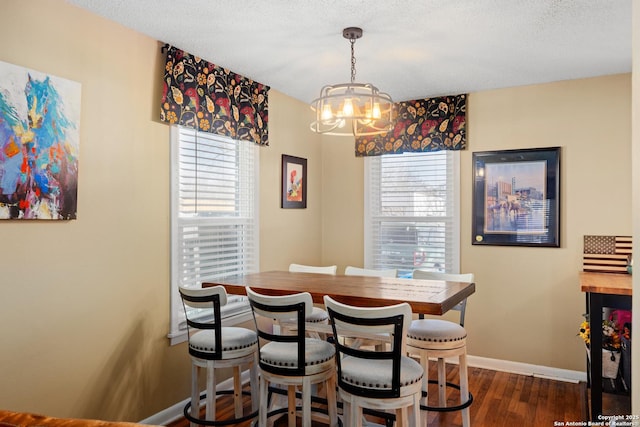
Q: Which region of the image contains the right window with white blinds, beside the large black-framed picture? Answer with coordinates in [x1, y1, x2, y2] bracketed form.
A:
[365, 151, 460, 277]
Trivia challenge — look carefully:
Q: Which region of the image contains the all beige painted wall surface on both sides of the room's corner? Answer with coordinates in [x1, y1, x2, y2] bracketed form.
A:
[0, 0, 631, 421]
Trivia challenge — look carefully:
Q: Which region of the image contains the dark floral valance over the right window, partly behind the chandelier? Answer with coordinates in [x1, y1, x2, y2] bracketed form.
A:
[356, 94, 467, 157]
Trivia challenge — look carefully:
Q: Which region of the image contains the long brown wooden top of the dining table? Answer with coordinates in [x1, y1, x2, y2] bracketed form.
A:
[203, 271, 476, 315]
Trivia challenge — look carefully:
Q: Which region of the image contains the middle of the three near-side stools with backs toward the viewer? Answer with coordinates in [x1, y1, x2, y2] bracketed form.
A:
[246, 287, 338, 427]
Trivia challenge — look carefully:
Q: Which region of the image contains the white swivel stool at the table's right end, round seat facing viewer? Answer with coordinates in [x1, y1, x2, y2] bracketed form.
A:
[407, 270, 474, 427]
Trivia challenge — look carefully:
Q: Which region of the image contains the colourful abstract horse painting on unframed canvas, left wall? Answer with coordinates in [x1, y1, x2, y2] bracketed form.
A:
[0, 61, 80, 220]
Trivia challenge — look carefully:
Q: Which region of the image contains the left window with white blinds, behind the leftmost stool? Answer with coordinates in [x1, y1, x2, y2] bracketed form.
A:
[169, 126, 259, 344]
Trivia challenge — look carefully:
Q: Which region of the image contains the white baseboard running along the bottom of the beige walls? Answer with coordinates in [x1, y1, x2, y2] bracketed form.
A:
[139, 355, 587, 426]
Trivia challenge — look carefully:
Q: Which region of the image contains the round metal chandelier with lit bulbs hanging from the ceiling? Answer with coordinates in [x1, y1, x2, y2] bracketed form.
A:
[311, 27, 393, 136]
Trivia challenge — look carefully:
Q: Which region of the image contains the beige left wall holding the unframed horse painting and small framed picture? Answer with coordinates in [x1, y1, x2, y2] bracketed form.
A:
[0, 0, 322, 421]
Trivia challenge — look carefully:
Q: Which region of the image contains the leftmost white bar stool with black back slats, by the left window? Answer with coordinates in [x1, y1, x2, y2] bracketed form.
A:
[179, 286, 258, 427]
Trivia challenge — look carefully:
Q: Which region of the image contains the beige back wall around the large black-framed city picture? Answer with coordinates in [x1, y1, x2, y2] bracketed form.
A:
[322, 75, 631, 370]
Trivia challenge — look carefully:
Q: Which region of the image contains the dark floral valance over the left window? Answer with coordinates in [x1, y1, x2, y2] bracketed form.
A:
[160, 46, 269, 145]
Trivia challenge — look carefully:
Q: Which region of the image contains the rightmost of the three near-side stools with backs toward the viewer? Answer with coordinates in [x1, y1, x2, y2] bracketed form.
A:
[324, 296, 423, 427]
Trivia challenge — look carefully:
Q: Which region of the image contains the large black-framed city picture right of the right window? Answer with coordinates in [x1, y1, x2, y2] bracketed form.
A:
[472, 147, 560, 248]
